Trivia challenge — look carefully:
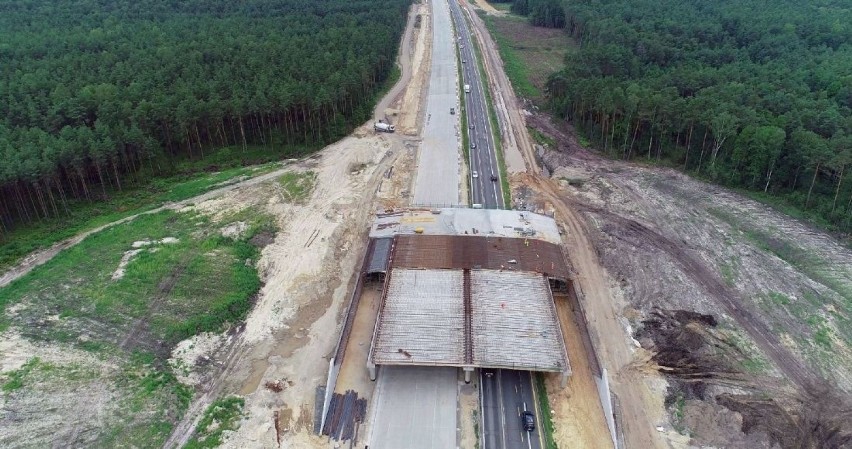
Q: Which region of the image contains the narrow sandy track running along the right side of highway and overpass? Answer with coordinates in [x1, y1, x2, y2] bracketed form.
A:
[461, 1, 666, 449]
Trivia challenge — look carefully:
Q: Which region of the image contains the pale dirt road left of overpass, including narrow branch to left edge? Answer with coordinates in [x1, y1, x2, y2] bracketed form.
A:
[0, 6, 424, 448]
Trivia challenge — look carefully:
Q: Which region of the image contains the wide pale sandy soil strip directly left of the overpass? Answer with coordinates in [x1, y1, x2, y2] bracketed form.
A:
[166, 135, 401, 447]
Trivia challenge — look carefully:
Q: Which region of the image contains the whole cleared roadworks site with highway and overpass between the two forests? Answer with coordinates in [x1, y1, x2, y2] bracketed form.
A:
[0, 0, 852, 449]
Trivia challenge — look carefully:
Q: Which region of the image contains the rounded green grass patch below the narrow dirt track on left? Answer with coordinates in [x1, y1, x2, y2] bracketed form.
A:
[0, 207, 271, 349]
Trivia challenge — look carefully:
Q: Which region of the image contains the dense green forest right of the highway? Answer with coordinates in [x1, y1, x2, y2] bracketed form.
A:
[544, 0, 852, 232]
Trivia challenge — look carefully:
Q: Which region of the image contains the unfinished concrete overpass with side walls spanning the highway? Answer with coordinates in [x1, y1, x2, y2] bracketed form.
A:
[317, 208, 608, 447]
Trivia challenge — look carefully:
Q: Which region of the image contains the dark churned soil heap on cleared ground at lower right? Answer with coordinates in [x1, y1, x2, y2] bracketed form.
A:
[636, 310, 852, 449]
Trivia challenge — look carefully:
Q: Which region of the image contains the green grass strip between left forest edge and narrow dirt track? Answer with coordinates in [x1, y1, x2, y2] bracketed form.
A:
[0, 154, 280, 271]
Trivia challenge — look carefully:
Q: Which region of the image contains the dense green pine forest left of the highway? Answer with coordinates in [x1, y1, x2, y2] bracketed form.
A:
[0, 0, 410, 238]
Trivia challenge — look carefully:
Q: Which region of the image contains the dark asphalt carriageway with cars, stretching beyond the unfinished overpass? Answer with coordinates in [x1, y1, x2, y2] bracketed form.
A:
[449, 0, 504, 209]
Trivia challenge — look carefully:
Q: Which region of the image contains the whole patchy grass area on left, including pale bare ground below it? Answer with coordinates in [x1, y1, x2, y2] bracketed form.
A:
[0, 204, 275, 447]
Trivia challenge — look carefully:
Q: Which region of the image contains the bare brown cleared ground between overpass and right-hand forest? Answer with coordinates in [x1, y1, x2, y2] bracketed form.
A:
[527, 111, 852, 447]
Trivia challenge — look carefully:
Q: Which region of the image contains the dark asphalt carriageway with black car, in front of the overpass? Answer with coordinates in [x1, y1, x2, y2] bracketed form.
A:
[479, 370, 542, 449]
